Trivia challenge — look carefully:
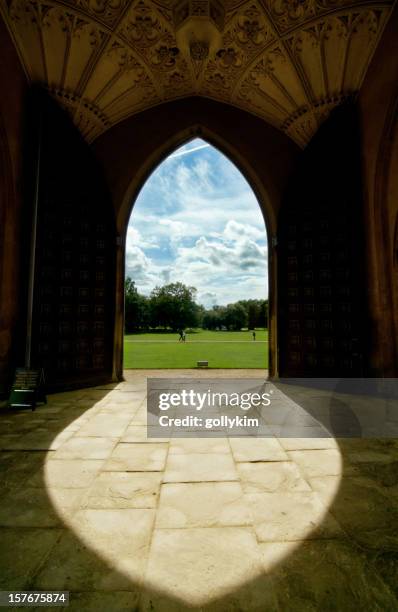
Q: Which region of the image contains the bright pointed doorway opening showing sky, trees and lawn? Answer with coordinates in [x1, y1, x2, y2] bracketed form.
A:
[124, 138, 269, 369]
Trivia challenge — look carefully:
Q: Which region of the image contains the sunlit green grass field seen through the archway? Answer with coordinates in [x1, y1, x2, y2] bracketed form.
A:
[124, 329, 268, 369]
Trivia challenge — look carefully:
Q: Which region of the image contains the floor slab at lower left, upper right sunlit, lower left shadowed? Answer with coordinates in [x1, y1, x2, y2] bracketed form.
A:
[33, 509, 154, 591]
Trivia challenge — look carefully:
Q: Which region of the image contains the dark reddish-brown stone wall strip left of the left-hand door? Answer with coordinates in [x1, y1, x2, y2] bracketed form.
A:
[0, 20, 27, 395]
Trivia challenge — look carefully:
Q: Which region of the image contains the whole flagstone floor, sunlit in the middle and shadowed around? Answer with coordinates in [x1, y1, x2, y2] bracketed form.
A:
[0, 370, 398, 612]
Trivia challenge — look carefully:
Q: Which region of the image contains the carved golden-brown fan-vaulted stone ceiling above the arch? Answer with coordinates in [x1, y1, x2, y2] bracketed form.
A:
[0, 0, 392, 147]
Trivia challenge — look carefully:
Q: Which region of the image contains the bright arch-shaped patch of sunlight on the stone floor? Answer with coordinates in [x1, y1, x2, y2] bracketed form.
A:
[40, 371, 343, 609]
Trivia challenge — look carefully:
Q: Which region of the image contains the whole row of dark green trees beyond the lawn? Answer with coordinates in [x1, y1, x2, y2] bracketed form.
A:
[125, 277, 268, 333]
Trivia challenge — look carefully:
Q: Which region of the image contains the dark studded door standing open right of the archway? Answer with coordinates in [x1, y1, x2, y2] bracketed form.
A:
[277, 106, 367, 377]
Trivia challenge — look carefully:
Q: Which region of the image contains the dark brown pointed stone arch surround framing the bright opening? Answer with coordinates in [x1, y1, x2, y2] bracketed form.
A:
[93, 98, 299, 379]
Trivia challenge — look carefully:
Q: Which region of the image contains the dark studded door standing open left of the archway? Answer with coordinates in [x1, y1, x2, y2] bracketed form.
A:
[32, 95, 116, 387]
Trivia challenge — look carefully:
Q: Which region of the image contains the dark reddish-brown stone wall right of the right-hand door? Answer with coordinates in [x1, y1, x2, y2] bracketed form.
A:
[359, 2, 398, 376]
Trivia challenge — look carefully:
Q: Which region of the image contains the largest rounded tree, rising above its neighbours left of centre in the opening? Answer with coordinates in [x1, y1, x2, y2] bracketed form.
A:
[150, 283, 200, 331]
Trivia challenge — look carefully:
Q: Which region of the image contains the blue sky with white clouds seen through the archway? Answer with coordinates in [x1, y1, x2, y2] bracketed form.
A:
[126, 138, 268, 308]
